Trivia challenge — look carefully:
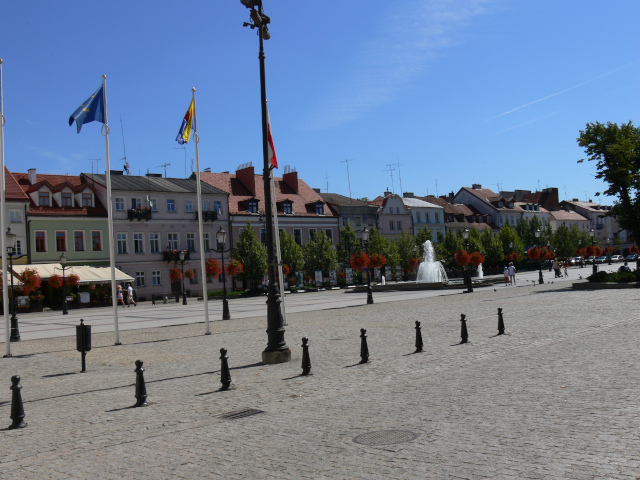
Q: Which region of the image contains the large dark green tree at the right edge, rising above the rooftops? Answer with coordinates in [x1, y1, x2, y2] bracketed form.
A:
[577, 121, 640, 243]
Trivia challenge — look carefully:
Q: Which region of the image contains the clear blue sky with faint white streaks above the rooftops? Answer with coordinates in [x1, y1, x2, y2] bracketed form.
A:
[0, 0, 640, 203]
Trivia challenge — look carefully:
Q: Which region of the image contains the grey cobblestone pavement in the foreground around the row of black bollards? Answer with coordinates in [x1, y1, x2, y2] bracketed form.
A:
[0, 283, 640, 480]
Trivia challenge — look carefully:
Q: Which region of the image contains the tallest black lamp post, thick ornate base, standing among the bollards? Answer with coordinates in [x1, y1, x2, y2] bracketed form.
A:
[240, 0, 291, 364]
